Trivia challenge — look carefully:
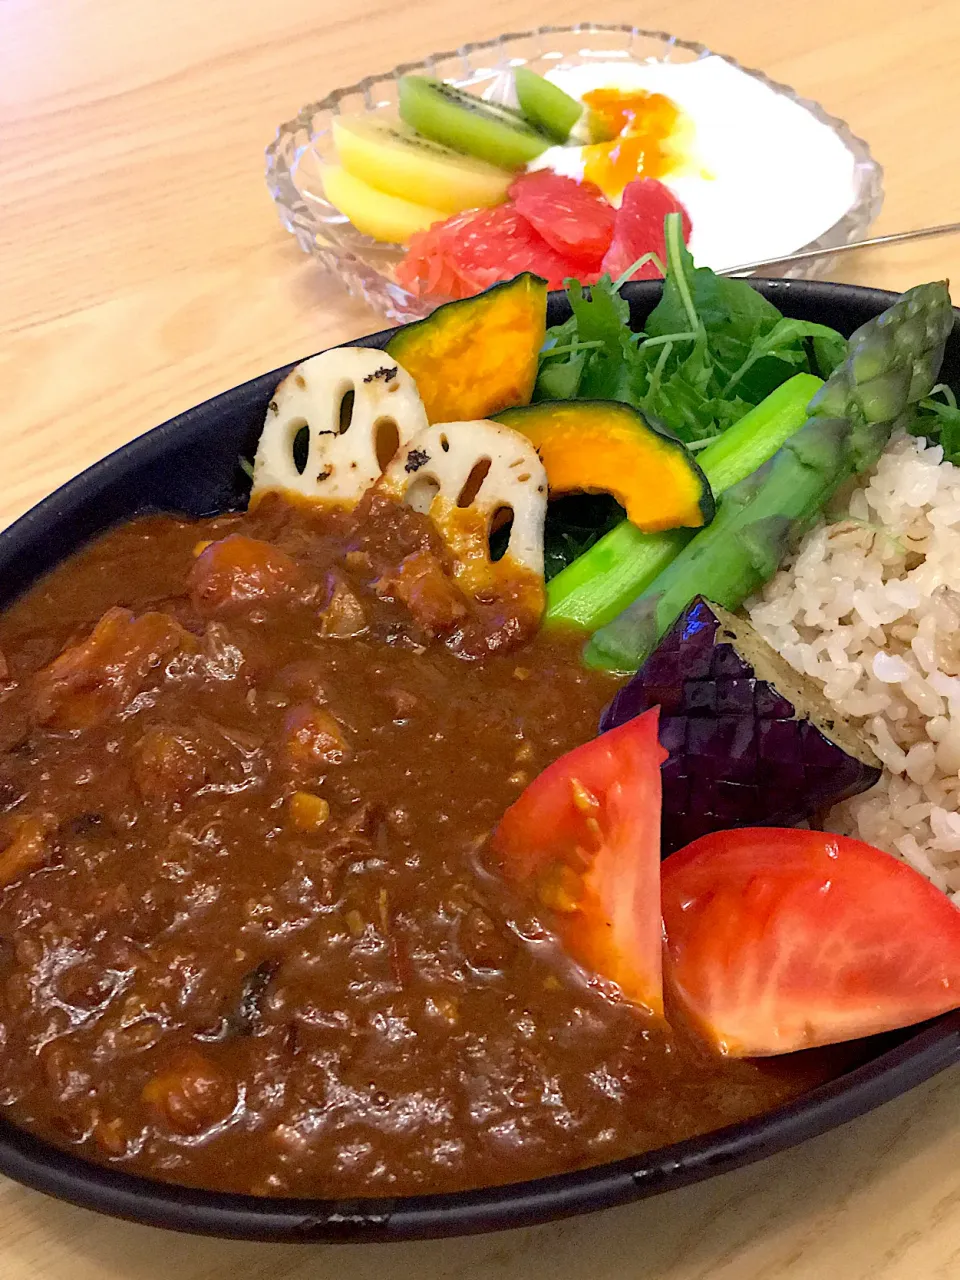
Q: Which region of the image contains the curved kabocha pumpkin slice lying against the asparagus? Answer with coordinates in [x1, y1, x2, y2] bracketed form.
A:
[497, 401, 713, 534]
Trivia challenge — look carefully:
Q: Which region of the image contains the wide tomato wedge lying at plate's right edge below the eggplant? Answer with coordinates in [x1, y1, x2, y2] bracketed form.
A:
[662, 827, 960, 1057]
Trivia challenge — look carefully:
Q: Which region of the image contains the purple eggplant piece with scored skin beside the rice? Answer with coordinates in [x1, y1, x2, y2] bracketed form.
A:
[600, 596, 881, 858]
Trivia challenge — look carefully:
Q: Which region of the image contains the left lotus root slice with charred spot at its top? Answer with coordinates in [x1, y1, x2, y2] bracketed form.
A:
[251, 347, 426, 507]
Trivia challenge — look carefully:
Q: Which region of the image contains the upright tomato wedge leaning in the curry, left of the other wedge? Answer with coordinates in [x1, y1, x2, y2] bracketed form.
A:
[492, 707, 667, 1015]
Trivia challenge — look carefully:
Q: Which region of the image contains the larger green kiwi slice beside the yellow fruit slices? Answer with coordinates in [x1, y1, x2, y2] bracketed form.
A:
[399, 76, 550, 169]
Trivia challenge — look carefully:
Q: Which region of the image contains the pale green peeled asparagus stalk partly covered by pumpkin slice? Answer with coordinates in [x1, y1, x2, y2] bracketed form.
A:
[545, 374, 823, 631]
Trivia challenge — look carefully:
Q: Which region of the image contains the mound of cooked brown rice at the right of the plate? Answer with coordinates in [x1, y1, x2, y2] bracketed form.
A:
[748, 435, 960, 904]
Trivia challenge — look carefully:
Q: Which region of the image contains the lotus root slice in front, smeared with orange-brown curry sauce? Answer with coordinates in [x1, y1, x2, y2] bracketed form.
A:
[380, 420, 547, 596]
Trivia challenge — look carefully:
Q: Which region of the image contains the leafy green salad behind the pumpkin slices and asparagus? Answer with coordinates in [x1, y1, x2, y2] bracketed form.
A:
[534, 214, 849, 577]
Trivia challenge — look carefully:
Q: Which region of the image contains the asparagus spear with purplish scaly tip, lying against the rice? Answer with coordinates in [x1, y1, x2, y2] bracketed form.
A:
[585, 283, 954, 672]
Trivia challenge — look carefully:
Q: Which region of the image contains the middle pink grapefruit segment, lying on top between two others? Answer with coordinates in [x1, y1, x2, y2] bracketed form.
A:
[508, 169, 616, 271]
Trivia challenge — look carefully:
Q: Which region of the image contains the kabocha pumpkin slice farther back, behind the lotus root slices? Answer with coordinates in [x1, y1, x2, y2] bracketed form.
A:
[387, 273, 547, 422]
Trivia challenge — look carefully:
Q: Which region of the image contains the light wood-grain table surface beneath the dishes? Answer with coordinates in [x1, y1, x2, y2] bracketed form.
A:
[0, 0, 960, 1280]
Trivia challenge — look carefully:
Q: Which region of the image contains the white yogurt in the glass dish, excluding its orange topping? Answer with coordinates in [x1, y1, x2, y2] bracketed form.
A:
[530, 55, 856, 270]
